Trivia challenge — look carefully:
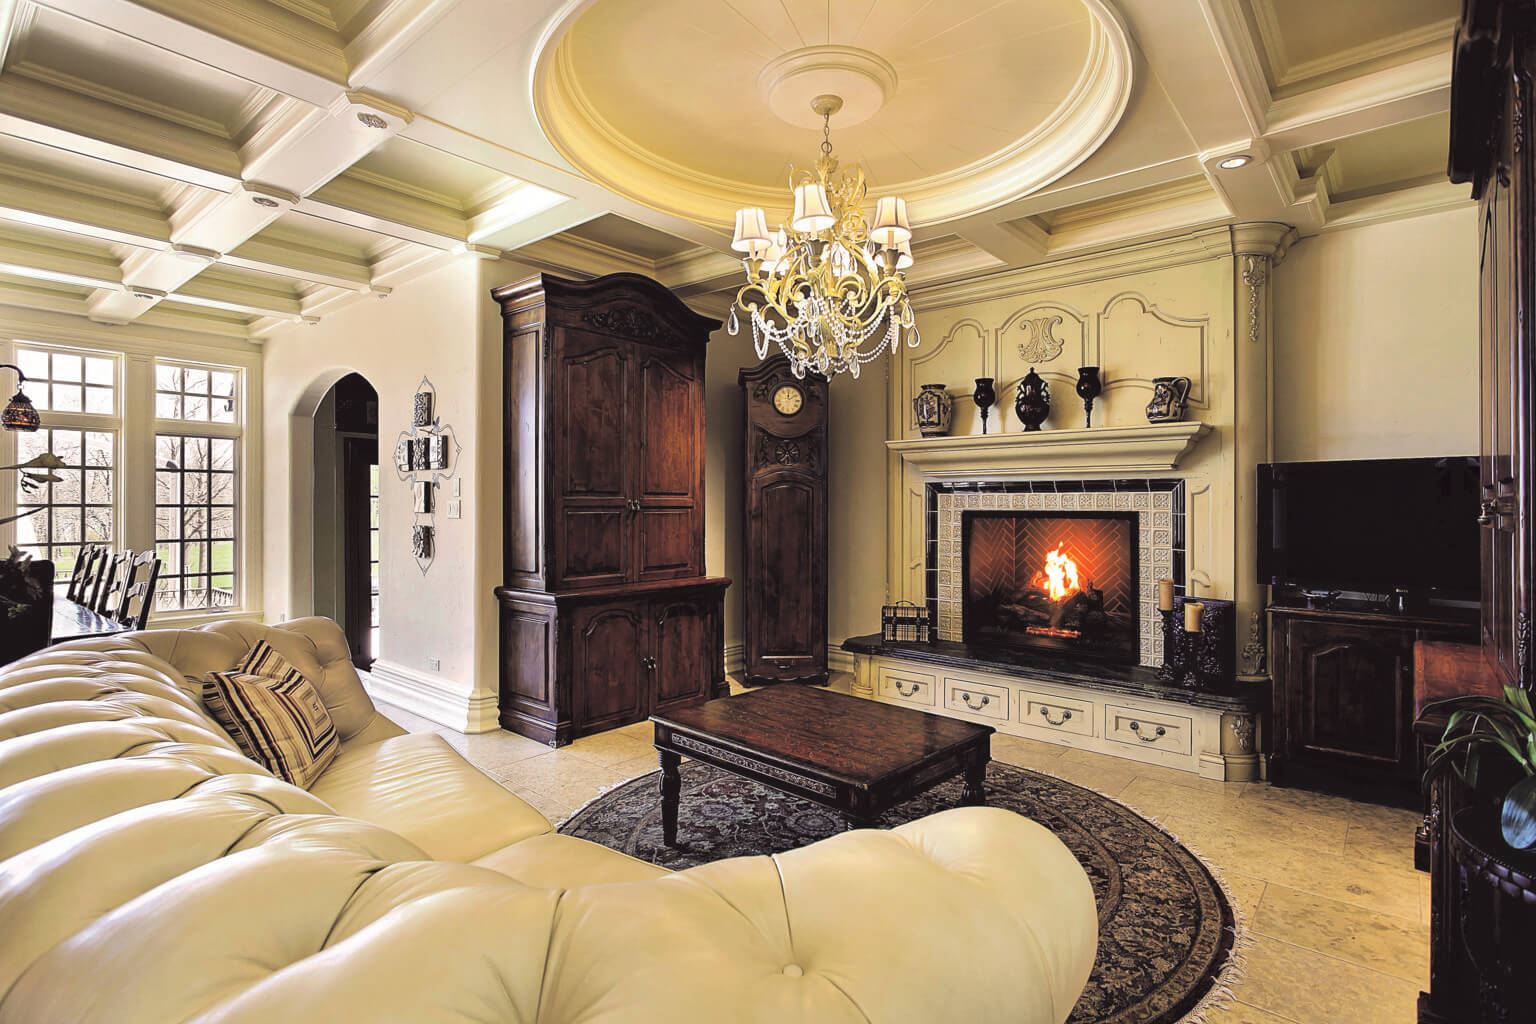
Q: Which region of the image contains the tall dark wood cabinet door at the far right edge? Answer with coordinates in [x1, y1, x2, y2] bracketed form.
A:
[1479, 62, 1533, 686]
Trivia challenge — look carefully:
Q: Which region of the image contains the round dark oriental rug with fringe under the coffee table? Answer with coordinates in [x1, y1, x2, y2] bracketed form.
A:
[559, 761, 1236, 1024]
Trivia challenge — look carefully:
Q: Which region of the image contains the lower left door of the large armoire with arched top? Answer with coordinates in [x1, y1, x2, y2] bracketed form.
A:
[567, 600, 651, 735]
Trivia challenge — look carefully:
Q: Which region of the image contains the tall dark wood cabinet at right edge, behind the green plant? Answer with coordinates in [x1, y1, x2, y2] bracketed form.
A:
[1416, 0, 1536, 1024]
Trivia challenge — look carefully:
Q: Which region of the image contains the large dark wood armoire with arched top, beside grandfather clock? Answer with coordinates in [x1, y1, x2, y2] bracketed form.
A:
[492, 273, 730, 746]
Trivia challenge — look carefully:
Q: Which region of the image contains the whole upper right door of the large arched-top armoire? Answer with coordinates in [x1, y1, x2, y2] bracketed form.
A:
[633, 345, 703, 582]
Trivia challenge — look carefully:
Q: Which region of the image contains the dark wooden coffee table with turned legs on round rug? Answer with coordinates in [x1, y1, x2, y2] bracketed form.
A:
[651, 683, 994, 846]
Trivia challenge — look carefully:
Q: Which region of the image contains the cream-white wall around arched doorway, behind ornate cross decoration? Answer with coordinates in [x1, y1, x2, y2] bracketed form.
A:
[264, 256, 497, 727]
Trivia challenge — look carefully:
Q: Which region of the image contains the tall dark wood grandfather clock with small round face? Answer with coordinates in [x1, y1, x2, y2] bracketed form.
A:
[737, 356, 826, 686]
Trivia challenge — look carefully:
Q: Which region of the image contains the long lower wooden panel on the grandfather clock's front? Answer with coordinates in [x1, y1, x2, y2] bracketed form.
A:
[751, 476, 825, 659]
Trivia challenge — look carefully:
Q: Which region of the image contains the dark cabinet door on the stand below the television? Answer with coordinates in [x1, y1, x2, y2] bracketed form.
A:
[1289, 623, 1413, 774]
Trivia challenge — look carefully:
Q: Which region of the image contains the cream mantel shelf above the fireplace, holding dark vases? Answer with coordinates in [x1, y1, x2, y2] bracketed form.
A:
[885, 422, 1210, 481]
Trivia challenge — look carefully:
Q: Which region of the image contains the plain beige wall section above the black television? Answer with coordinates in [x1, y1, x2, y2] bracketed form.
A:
[1272, 206, 1478, 462]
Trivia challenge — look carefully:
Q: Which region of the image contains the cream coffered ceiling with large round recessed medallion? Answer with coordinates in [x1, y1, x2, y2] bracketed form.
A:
[0, 0, 1468, 341]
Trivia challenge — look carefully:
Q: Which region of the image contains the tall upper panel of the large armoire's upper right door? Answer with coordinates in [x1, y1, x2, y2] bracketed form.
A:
[634, 352, 702, 502]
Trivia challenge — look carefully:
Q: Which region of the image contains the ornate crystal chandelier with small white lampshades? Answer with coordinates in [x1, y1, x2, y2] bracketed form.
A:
[730, 95, 919, 378]
